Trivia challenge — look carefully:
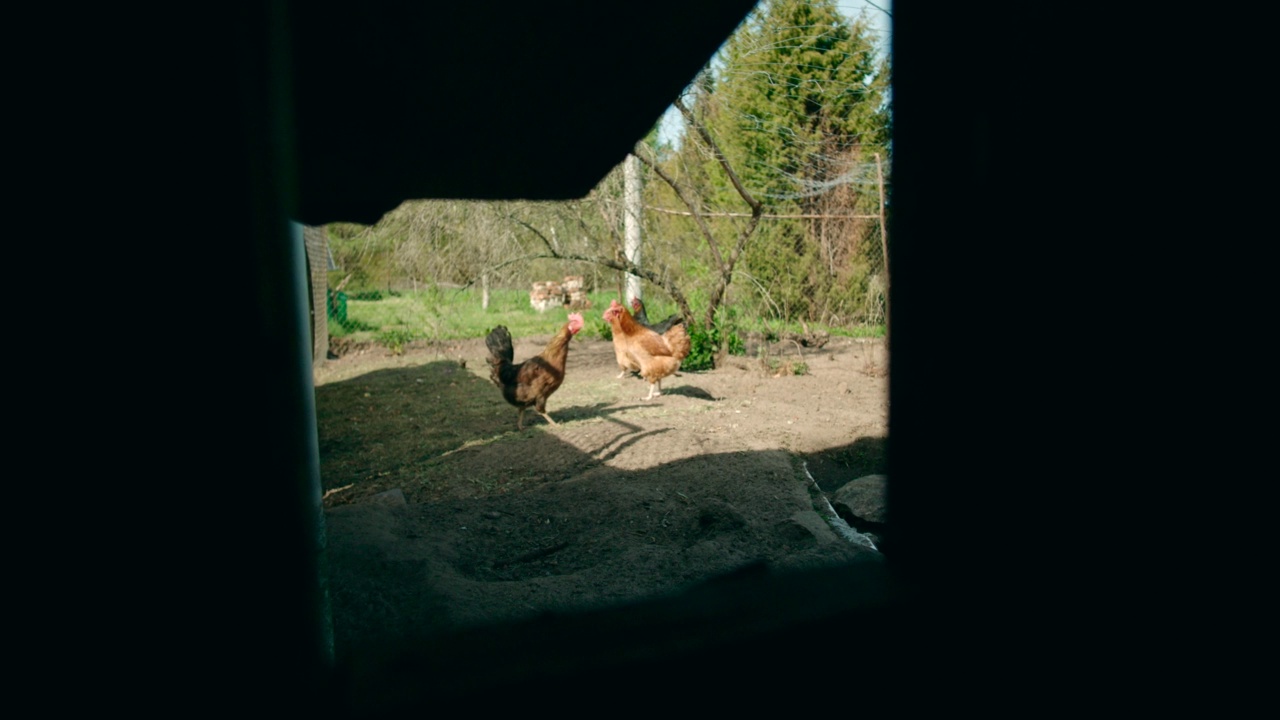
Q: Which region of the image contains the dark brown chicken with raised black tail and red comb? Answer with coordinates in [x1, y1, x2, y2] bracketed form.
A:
[484, 313, 582, 430]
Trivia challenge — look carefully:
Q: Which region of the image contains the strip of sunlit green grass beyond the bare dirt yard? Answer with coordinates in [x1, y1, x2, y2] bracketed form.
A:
[329, 288, 884, 350]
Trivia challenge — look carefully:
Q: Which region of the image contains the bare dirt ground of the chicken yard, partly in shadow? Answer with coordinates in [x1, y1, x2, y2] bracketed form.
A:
[315, 323, 887, 655]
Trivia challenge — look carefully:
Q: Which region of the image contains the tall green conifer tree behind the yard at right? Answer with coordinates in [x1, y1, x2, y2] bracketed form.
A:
[681, 0, 890, 319]
